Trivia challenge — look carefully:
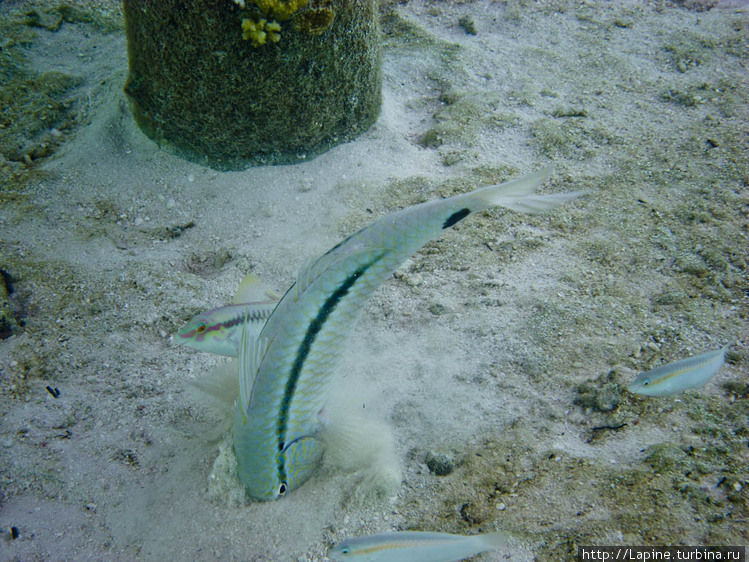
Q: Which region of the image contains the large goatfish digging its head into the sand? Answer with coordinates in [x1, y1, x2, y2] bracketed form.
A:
[233, 170, 580, 500]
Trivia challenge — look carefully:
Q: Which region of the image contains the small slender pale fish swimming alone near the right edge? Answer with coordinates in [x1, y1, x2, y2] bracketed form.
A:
[629, 346, 728, 396]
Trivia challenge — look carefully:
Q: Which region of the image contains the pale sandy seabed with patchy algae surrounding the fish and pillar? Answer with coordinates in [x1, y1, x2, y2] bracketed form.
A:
[0, 0, 749, 561]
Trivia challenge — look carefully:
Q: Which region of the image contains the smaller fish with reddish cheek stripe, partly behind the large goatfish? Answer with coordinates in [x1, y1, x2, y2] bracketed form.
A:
[175, 273, 279, 357]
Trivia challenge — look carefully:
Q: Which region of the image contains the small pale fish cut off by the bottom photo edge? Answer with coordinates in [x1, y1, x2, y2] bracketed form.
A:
[328, 531, 509, 562]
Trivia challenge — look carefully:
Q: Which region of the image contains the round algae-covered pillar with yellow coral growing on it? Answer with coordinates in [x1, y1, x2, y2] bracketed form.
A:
[124, 0, 381, 169]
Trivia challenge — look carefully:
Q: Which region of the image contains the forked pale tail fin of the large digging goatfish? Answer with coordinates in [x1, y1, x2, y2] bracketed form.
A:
[471, 167, 586, 214]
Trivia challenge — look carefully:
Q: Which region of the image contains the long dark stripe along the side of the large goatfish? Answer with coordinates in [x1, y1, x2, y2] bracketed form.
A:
[278, 255, 382, 476]
